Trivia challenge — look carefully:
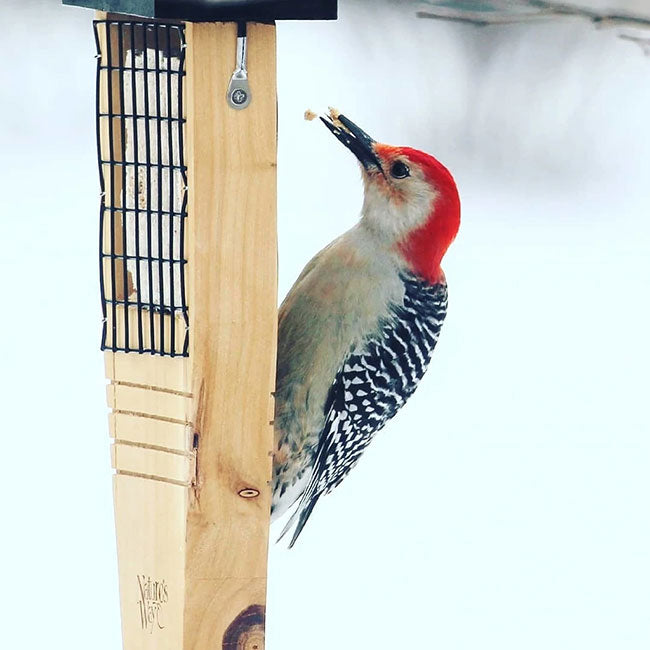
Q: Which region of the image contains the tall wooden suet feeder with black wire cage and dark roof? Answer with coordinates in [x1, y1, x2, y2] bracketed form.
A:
[64, 0, 336, 650]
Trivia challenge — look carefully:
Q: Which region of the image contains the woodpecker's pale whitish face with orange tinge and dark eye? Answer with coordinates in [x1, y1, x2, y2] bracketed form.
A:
[362, 144, 439, 245]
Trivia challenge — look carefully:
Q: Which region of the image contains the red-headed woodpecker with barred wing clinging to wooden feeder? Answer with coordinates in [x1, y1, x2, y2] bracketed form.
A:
[272, 111, 460, 546]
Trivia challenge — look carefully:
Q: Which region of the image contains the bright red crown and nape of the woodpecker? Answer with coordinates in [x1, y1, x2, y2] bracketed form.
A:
[395, 147, 460, 284]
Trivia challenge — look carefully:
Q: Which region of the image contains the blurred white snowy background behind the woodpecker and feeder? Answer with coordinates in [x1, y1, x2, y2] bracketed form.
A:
[0, 0, 650, 650]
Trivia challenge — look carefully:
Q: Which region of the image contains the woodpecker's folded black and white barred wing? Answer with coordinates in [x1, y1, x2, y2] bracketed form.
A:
[282, 281, 447, 547]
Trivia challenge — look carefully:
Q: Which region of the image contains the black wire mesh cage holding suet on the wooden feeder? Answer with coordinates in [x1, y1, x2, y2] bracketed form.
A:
[94, 19, 189, 356]
